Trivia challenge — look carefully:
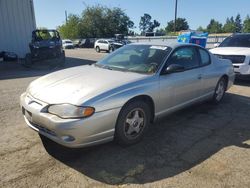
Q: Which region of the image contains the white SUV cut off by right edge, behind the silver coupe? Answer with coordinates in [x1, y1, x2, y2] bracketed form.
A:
[210, 33, 250, 76]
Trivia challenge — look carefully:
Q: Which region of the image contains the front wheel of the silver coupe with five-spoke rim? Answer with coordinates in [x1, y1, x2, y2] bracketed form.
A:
[115, 101, 151, 146]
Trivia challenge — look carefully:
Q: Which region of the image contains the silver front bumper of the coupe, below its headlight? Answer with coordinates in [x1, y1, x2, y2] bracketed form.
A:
[20, 93, 120, 148]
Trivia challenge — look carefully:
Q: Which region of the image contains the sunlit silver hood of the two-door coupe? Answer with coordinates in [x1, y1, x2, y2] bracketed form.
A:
[27, 65, 148, 105]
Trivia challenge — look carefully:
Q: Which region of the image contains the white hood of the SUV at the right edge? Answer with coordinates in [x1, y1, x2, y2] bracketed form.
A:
[210, 47, 250, 55]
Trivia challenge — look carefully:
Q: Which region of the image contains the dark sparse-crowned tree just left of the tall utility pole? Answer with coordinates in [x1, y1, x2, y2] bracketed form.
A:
[139, 13, 160, 33]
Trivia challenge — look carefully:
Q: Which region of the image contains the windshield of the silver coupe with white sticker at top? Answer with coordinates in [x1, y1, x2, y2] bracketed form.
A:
[95, 45, 171, 74]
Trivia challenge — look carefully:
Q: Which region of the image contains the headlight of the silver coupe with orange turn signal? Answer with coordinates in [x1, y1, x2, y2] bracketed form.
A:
[48, 104, 95, 119]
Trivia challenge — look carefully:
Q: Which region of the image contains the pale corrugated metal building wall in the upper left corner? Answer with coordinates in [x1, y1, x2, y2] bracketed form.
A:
[0, 0, 36, 58]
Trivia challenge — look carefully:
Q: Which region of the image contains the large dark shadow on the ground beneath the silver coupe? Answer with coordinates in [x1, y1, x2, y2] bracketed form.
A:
[41, 94, 250, 185]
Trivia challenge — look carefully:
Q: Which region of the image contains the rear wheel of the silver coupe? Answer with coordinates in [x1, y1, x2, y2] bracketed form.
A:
[212, 77, 227, 104]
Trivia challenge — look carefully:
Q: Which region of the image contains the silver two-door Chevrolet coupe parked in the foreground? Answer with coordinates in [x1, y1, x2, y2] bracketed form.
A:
[20, 44, 235, 148]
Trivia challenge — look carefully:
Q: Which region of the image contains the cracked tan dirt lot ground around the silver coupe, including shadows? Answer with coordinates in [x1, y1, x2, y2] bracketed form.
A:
[0, 49, 250, 188]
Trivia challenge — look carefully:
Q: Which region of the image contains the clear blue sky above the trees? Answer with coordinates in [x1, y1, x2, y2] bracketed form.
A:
[33, 0, 250, 32]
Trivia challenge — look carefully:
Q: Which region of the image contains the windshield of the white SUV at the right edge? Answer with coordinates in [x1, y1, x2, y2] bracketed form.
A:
[219, 35, 250, 48]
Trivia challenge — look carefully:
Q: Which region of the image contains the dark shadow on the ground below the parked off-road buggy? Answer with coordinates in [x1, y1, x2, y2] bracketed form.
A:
[0, 57, 95, 80]
